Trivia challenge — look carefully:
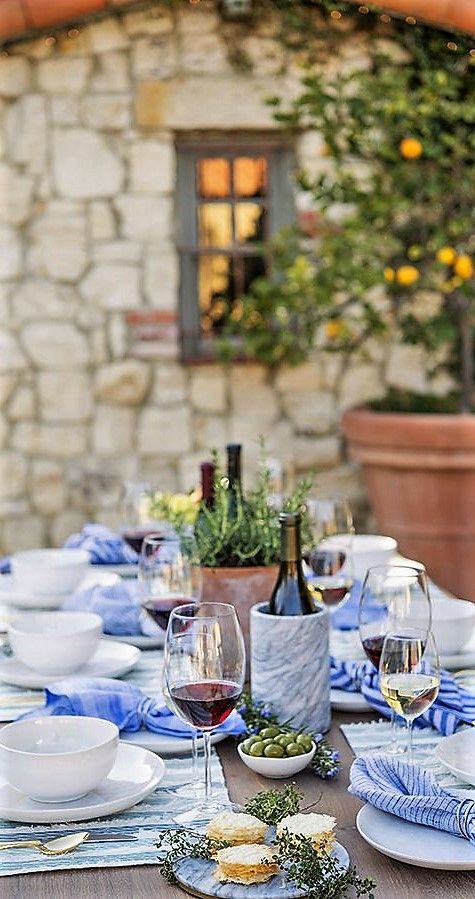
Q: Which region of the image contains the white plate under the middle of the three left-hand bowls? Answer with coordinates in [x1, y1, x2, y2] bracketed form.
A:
[0, 640, 140, 690]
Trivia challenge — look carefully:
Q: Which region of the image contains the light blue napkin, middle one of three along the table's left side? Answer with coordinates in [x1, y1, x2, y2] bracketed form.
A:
[63, 583, 155, 637]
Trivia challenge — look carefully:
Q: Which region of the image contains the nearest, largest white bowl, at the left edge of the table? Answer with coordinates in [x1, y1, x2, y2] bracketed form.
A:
[0, 715, 119, 800]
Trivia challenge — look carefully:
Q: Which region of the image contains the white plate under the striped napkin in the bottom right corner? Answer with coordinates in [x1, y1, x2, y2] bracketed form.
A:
[356, 805, 475, 871]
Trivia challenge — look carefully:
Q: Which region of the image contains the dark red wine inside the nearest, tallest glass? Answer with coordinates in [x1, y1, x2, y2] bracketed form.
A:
[170, 680, 242, 729]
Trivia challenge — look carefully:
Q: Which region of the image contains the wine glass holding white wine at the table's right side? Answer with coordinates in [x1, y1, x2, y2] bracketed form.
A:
[379, 628, 440, 764]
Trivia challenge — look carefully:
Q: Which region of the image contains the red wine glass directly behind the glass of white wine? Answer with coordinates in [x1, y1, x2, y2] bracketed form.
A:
[358, 564, 432, 752]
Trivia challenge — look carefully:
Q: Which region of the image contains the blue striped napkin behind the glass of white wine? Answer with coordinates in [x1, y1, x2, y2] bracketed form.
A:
[330, 657, 475, 736]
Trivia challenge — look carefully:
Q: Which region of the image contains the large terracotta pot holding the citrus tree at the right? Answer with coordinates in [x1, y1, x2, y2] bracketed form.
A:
[342, 409, 475, 601]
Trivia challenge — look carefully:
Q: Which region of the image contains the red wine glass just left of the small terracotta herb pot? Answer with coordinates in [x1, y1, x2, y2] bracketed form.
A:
[138, 533, 202, 630]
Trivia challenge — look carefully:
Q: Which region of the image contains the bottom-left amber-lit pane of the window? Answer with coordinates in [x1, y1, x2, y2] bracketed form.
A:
[198, 256, 234, 334]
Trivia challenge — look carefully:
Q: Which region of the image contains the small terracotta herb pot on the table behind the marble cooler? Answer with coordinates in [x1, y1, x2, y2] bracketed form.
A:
[202, 565, 278, 670]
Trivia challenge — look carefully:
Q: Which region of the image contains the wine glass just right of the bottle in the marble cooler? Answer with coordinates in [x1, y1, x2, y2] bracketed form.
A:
[307, 544, 354, 614]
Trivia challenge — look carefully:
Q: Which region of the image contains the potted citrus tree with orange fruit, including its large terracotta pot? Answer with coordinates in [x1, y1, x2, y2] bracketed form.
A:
[223, 8, 475, 600]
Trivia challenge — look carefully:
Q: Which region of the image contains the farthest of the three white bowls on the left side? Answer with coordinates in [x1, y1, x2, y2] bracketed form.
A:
[11, 549, 89, 596]
